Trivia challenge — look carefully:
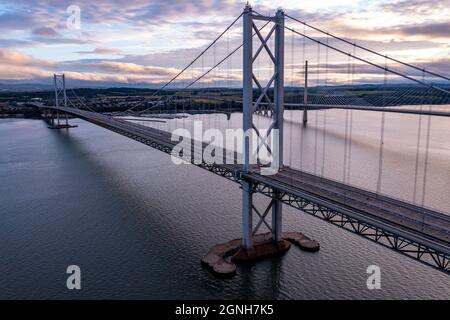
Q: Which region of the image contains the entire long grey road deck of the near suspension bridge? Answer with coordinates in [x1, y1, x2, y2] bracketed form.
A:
[35, 106, 450, 271]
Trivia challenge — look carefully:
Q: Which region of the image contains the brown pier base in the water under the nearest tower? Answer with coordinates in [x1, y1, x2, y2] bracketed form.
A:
[201, 232, 320, 276]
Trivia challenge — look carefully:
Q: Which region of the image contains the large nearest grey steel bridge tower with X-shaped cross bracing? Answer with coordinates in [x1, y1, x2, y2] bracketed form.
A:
[242, 5, 284, 252]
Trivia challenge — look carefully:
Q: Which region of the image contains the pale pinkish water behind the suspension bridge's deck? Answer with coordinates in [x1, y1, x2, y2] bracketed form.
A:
[129, 106, 450, 213]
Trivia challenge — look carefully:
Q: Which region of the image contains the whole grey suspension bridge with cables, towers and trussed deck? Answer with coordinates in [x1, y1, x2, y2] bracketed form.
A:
[29, 6, 450, 273]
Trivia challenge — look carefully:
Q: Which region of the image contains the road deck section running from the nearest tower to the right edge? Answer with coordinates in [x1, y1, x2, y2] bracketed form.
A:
[243, 168, 450, 252]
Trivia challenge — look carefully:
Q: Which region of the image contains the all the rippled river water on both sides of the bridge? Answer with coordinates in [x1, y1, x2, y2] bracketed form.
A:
[0, 111, 450, 299]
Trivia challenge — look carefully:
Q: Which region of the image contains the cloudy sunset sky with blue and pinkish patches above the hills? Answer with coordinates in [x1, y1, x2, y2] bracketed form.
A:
[0, 0, 450, 87]
